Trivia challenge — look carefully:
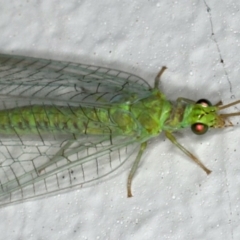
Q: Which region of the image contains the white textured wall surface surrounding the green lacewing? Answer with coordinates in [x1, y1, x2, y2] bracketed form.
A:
[0, 0, 240, 240]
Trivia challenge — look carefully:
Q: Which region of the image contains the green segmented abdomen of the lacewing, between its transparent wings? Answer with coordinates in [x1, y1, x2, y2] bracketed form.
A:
[0, 105, 105, 134]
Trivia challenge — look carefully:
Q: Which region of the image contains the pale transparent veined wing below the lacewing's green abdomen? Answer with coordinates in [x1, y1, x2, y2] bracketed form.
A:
[0, 136, 139, 206]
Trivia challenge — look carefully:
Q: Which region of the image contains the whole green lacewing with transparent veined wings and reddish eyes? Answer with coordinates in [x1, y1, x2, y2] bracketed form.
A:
[0, 55, 240, 205]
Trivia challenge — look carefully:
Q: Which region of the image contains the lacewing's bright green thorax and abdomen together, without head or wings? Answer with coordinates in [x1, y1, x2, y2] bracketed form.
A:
[0, 90, 171, 139]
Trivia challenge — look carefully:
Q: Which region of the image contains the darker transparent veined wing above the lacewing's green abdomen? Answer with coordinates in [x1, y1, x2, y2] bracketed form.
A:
[0, 55, 151, 107]
